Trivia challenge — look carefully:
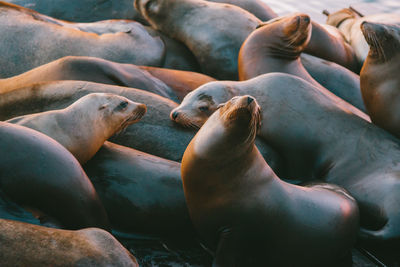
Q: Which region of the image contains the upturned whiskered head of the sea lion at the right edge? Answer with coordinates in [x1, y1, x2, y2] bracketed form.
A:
[360, 21, 400, 62]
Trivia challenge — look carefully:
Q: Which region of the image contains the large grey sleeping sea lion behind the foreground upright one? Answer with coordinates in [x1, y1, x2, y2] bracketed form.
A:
[171, 73, 400, 245]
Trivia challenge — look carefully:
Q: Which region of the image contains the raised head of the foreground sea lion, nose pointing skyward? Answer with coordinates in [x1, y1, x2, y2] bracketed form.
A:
[193, 95, 261, 161]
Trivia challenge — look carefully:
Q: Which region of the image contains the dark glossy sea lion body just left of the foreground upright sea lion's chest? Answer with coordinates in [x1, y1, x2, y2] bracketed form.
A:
[83, 142, 194, 238]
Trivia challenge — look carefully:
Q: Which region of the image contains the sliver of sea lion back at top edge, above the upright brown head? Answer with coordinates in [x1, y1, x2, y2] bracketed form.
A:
[208, 0, 278, 21]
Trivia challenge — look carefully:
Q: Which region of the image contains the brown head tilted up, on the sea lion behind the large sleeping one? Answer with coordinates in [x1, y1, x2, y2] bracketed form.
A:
[256, 13, 312, 57]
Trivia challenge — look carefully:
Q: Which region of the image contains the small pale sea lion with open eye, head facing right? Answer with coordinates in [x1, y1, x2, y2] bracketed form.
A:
[7, 93, 146, 164]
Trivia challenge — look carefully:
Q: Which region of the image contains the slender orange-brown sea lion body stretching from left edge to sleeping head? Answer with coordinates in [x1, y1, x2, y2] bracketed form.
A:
[0, 56, 215, 102]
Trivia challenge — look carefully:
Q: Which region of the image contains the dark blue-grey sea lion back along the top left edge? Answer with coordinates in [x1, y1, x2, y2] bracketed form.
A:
[7, 0, 145, 23]
